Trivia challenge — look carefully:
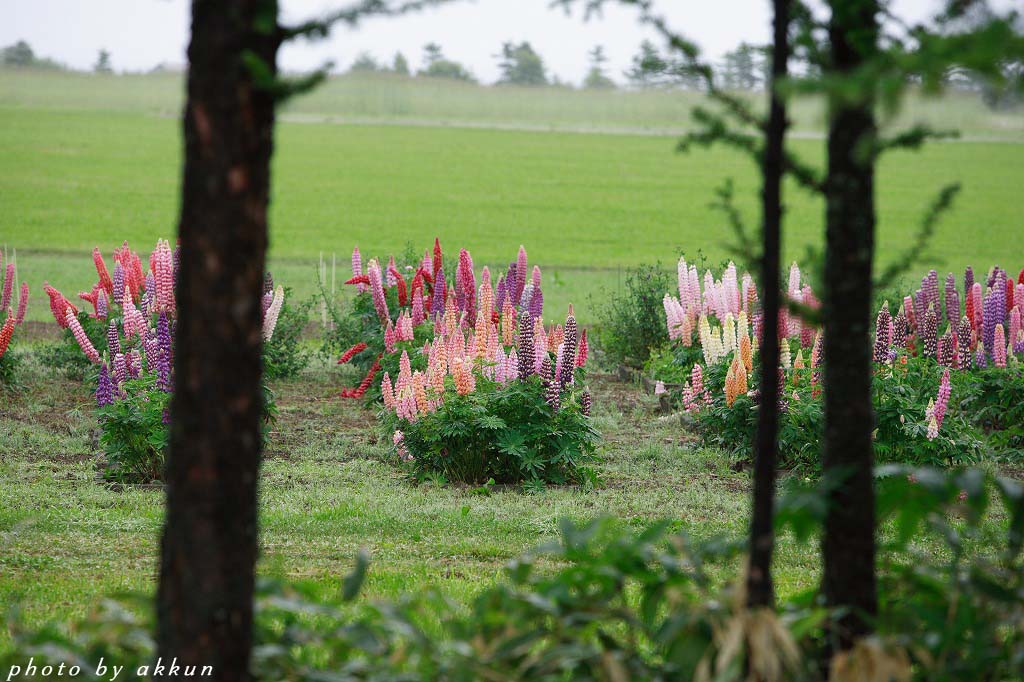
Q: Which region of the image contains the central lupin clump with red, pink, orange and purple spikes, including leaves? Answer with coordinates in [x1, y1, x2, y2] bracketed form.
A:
[339, 240, 598, 485]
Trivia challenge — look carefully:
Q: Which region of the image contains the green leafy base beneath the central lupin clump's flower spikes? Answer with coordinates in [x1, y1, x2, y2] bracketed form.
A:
[382, 375, 598, 483]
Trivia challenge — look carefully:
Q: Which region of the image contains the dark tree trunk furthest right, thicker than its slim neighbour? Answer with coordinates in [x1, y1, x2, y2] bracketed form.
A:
[822, 0, 879, 650]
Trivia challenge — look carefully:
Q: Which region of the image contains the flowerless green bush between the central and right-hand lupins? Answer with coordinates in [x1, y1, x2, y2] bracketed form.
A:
[594, 263, 672, 368]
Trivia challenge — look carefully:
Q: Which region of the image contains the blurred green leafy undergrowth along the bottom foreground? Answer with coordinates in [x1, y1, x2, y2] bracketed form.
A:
[9, 467, 1024, 682]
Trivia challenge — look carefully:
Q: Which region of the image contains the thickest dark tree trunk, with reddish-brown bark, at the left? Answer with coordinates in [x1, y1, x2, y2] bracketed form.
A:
[158, 0, 276, 680]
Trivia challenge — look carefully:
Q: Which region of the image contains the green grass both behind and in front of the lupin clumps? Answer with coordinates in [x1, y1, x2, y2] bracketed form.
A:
[0, 71, 1024, 649]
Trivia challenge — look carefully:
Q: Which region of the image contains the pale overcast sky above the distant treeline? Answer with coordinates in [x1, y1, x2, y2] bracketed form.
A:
[0, 0, 983, 83]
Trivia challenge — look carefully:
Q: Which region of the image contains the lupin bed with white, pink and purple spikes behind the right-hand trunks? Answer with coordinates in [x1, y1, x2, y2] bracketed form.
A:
[648, 261, 1024, 467]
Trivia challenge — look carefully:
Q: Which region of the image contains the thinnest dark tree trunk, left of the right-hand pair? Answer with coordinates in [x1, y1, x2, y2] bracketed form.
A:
[746, 0, 790, 607]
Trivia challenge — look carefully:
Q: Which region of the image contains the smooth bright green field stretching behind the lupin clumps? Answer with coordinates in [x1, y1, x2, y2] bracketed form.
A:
[0, 106, 1024, 323]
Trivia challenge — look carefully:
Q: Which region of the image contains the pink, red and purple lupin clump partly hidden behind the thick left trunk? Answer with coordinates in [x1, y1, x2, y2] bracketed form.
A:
[45, 240, 285, 483]
